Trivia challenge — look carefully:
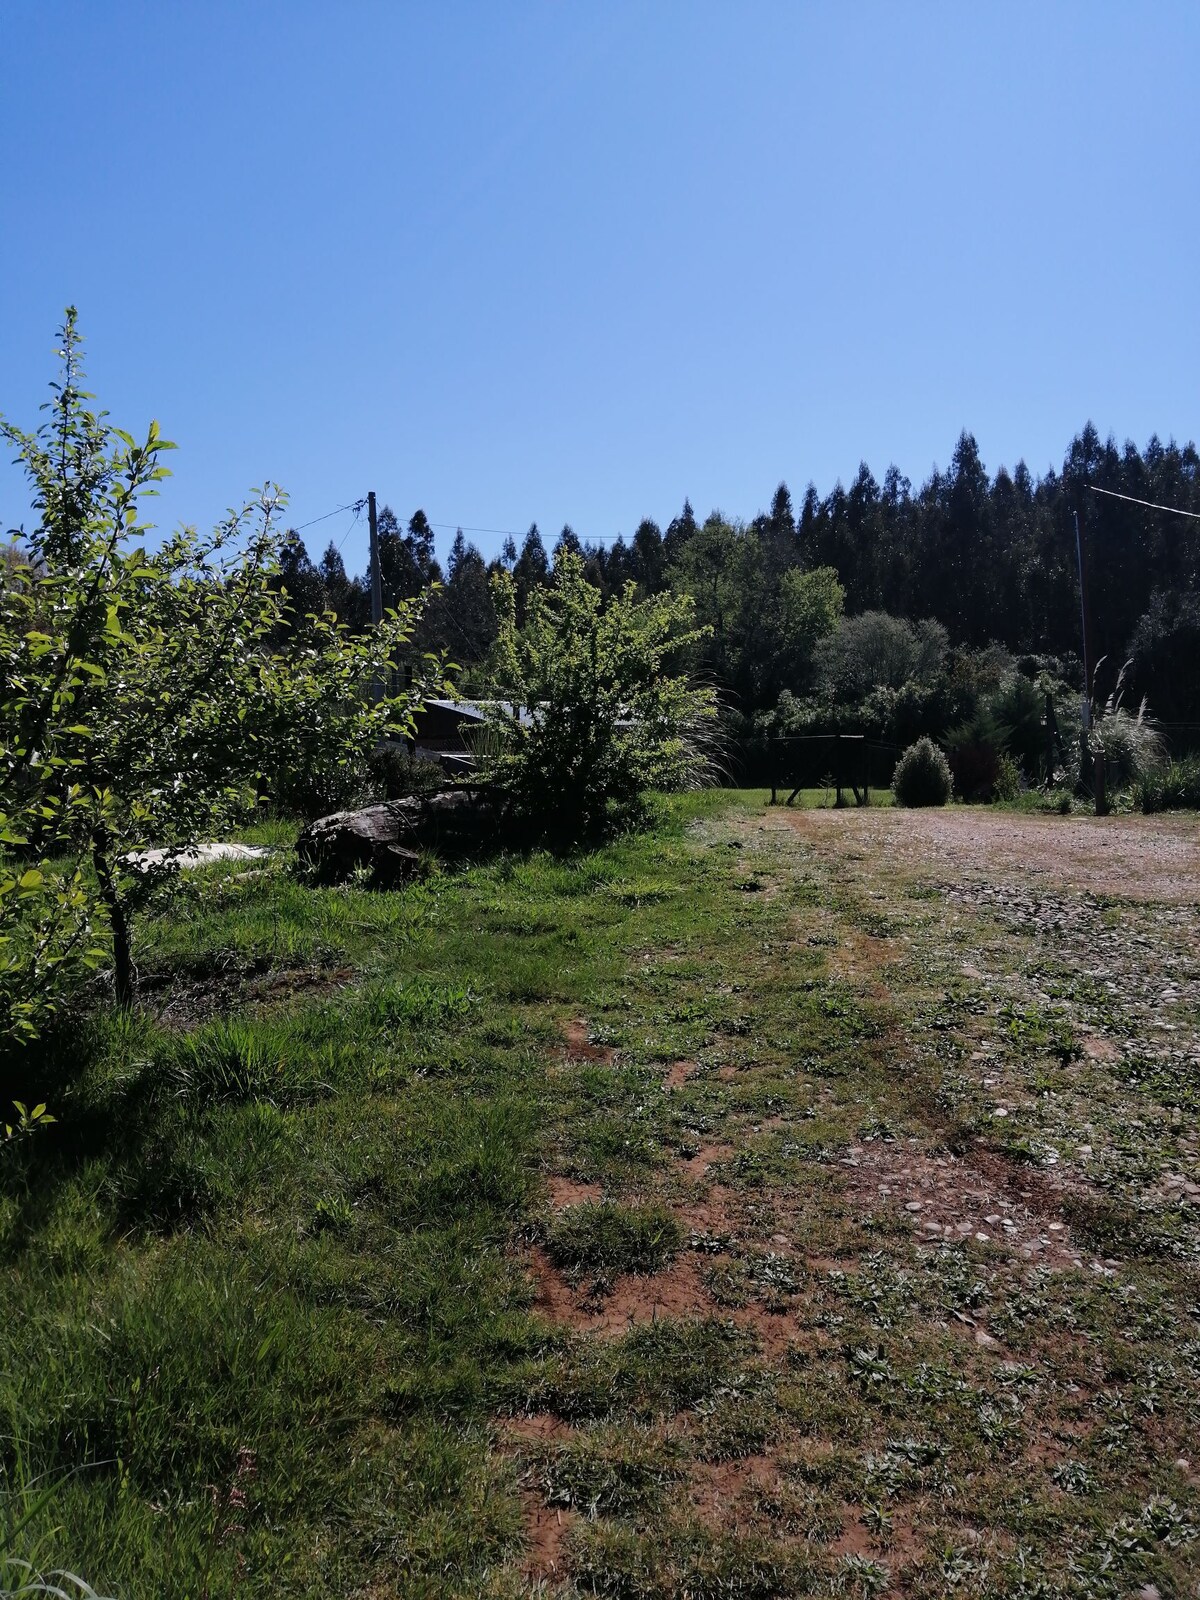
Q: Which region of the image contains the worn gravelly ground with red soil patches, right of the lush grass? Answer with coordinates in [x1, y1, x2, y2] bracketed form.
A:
[502, 810, 1200, 1600]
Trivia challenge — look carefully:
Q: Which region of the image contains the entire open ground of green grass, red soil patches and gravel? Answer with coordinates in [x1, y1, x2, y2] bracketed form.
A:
[0, 794, 1200, 1600]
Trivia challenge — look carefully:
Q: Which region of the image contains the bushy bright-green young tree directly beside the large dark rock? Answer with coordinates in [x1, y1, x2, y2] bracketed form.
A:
[485, 547, 717, 837]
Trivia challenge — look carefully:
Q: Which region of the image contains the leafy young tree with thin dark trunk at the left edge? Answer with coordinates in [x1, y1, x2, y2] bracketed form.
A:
[0, 309, 442, 1040]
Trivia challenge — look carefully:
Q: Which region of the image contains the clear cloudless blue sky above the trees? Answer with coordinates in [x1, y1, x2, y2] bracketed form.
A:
[0, 0, 1200, 570]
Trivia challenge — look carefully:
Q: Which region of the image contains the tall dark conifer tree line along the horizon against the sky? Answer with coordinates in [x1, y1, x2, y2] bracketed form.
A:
[280, 424, 1200, 722]
